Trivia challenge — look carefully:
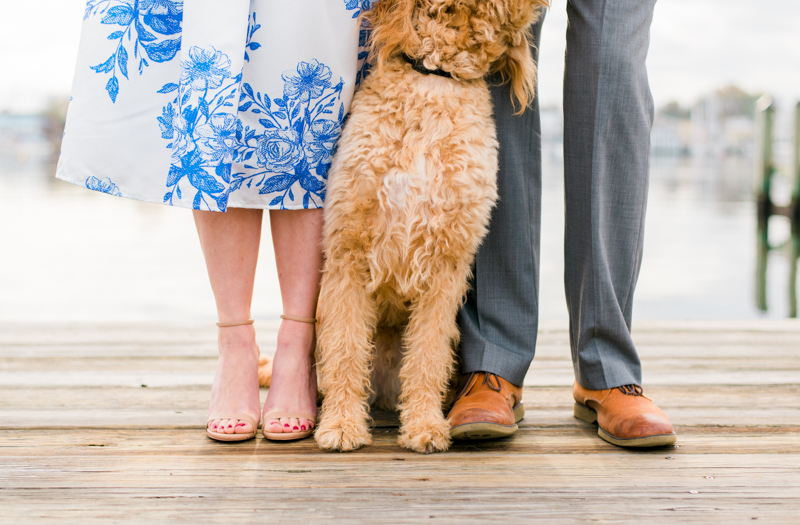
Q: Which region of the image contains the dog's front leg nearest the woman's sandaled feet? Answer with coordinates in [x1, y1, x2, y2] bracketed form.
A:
[314, 254, 377, 451]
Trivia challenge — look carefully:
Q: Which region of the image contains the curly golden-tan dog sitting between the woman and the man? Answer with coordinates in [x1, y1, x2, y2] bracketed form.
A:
[315, 0, 547, 453]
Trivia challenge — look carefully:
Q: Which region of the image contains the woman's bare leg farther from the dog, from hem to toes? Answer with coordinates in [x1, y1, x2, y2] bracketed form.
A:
[194, 208, 263, 434]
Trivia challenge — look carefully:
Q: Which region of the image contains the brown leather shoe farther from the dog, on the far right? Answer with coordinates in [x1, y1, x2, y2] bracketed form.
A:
[572, 382, 677, 447]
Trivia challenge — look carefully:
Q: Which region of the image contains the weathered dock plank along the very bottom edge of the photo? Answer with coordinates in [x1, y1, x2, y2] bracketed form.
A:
[1, 492, 798, 524]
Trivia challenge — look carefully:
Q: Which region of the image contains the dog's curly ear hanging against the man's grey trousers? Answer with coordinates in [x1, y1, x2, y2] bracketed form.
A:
[492, 0, 549, 115]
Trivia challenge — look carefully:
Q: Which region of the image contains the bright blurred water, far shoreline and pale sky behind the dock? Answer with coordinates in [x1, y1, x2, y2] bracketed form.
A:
[0, 0, 800, 322]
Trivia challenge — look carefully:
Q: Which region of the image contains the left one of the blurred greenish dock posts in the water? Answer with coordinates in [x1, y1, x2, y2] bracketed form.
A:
[754, 96, 775, 312]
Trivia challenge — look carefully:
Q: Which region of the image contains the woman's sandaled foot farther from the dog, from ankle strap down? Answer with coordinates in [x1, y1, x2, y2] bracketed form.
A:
[208, 325, 261, 434]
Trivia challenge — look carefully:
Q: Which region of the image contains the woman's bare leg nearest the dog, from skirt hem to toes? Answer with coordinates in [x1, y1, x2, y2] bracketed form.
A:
[263, 209, 323, 432]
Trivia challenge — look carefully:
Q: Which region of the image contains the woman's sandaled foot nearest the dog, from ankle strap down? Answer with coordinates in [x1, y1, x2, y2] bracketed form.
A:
[262, 320, 317, 433]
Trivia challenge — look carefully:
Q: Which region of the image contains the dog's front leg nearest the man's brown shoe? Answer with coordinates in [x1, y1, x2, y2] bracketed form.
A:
[398, 264, 469, 454]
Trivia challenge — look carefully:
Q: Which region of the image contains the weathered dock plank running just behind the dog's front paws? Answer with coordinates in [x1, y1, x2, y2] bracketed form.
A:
[0, 385, 800, 429]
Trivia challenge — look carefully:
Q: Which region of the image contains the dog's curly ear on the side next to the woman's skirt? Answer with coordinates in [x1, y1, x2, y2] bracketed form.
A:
[362, 0, 420, 75]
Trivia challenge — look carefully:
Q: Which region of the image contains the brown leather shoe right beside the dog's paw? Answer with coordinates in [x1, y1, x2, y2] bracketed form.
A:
[447, 372, 525, 439]
